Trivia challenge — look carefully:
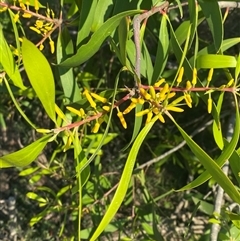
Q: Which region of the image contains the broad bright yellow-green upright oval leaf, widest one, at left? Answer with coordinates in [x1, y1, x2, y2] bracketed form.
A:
[22, 38, 56, 122]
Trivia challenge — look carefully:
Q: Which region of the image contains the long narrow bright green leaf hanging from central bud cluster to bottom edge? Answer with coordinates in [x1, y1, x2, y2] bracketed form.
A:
[90, 117, 157, 241]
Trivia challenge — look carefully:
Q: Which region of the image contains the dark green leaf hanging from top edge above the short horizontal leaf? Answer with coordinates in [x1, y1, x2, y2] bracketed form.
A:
[198, 0, 223, 53]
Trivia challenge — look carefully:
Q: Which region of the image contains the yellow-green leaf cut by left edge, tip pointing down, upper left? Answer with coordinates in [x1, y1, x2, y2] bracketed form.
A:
[0, 24, 26, 89]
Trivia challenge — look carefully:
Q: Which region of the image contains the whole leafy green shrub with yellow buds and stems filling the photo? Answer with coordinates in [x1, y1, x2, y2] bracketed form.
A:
[0, 0, 240, 241]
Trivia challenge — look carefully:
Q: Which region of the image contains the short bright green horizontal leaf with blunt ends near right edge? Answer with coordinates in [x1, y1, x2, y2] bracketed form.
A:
[197, 54, 237, 69]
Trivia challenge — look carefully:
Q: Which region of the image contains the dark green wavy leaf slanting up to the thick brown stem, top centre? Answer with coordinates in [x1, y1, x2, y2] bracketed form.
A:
[60, 10, 142, 67]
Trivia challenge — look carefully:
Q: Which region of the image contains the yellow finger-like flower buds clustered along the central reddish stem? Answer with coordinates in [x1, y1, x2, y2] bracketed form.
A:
[63, 67, 234, 133]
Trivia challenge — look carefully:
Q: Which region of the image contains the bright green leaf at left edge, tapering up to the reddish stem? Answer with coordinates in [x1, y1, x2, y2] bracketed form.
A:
[0, 135, 52, 168]
